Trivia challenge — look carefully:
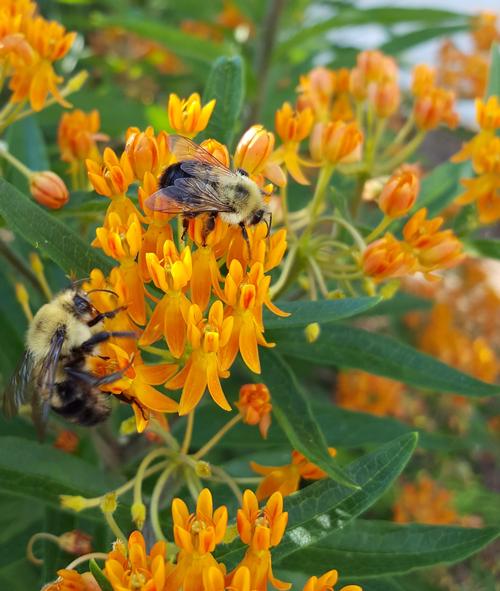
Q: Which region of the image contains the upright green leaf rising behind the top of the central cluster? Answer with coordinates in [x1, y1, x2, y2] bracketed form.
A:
[197, 56, 245, 148]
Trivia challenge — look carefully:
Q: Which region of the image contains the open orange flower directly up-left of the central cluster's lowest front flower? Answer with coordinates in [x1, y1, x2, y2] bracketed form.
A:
[140, 240, 192, 357]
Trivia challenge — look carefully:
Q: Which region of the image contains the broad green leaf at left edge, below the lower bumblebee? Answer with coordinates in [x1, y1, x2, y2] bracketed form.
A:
[0, 437, 122, 508]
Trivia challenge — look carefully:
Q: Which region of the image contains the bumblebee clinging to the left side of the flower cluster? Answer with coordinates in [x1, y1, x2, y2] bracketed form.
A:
[3, 287, 136, 436]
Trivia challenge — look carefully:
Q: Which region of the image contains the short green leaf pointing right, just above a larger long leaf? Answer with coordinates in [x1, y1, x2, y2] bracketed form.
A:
[264, 297, 381, 330]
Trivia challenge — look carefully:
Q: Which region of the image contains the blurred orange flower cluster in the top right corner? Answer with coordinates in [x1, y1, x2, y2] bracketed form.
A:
[438, 12, 500, 98]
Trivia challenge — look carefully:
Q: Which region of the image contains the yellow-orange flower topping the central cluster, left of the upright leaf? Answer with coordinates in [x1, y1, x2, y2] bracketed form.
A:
[168, 92, 215, 138]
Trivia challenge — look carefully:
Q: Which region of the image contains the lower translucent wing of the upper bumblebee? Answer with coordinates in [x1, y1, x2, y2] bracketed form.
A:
[146, 177, 235, 214]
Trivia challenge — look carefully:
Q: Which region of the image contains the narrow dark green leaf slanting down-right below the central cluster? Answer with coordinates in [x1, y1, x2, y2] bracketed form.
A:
[262, 351, 357, 487]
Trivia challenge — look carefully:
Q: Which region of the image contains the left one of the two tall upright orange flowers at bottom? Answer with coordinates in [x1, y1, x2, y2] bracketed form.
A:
[168, 488, 227, 591]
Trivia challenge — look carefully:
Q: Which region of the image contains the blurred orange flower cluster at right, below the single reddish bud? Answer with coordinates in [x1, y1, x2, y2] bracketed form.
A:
[363, 207, 464, 281]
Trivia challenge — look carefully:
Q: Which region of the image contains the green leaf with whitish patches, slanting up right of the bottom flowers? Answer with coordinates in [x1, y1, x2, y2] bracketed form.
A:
[217, 433, 417, 572]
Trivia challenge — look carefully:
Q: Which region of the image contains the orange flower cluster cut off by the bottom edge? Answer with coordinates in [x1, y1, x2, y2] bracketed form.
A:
[45, 489, 362, 591]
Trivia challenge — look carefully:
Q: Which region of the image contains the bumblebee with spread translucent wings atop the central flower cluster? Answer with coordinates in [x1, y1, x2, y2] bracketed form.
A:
[146, 135, 272, 245]
